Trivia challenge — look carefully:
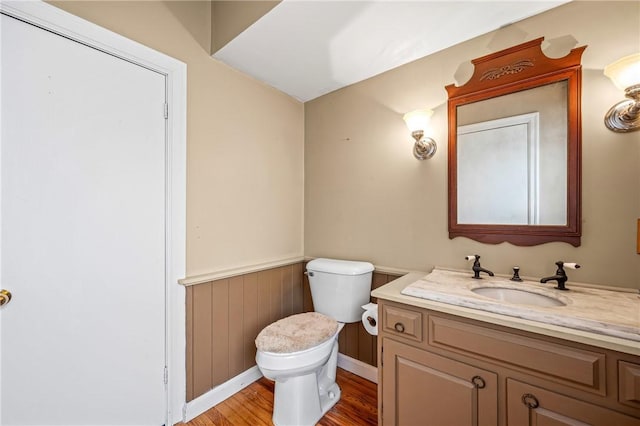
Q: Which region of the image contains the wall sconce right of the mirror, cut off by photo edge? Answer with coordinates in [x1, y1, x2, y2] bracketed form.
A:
[604, 53, 640, 133]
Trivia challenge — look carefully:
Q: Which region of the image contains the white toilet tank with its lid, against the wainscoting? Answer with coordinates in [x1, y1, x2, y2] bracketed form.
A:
[307, 259, 373, 323]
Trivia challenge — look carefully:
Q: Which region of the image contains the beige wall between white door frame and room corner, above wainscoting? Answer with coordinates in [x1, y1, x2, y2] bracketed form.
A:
[48, 1, 304, 276]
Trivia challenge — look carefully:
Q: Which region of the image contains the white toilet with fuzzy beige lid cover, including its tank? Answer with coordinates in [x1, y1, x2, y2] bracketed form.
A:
[256, 259, 373, 426]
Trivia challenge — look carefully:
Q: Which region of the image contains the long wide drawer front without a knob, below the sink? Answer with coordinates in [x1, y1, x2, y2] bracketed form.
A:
[429, 315, 606, 395]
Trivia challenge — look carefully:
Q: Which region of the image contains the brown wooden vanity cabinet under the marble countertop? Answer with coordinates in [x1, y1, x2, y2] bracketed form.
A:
[378, 299, 640, 426]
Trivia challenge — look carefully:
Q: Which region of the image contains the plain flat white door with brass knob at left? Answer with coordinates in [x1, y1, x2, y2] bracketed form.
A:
[0, 11, 166, 425]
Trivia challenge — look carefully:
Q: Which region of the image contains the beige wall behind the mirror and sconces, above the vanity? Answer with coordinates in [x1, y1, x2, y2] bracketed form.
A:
[305, 1, 640, 287]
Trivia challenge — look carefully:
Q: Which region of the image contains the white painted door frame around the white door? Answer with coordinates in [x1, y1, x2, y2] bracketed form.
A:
[0, 1, 187, 425]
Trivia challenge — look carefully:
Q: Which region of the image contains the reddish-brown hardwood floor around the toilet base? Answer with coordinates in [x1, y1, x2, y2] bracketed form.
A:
[186, 368, 378, 426]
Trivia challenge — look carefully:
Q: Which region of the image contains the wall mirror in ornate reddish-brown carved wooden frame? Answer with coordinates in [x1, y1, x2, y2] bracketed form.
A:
[446, 38, 586, 247]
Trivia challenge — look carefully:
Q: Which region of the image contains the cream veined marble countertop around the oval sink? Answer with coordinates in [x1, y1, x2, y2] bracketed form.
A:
[372, 268, 640, 355]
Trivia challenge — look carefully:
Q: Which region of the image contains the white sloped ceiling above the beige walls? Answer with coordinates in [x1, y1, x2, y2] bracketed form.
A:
[213, 0, 569, 102]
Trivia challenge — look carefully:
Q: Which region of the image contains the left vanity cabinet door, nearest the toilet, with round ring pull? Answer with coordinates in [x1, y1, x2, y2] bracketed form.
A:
[382, 339, 498, 426]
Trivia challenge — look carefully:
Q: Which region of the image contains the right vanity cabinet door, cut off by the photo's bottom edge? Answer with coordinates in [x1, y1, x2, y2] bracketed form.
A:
[507, 379, 640, 426]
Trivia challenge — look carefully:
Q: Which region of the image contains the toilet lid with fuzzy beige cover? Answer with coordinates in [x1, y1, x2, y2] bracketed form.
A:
[256, 312, 338, 353]
